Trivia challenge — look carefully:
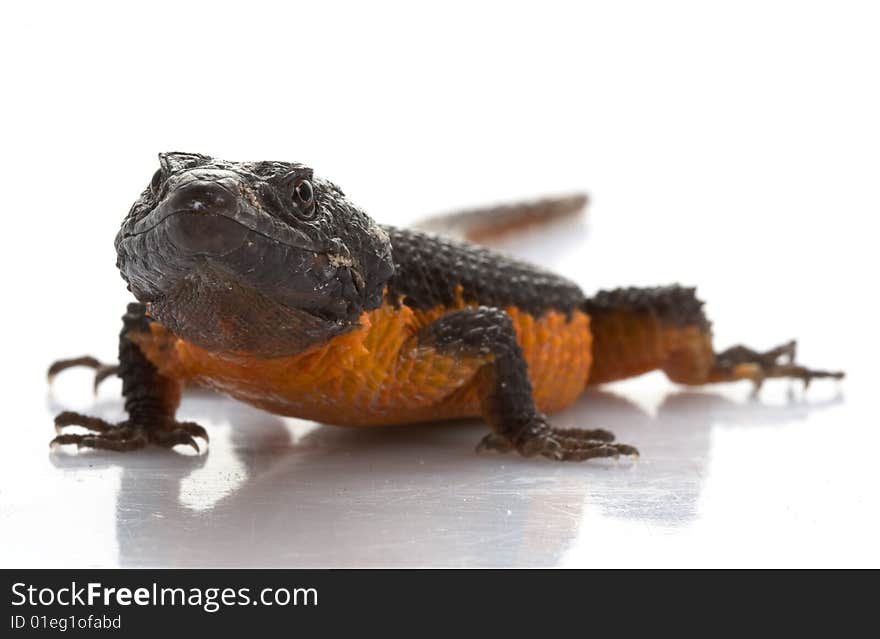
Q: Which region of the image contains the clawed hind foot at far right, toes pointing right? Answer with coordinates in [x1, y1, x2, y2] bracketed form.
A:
[716, 340, 845, 393]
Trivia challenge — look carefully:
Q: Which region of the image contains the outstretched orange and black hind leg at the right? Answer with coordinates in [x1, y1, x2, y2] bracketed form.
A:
[585, 286, 843, 389]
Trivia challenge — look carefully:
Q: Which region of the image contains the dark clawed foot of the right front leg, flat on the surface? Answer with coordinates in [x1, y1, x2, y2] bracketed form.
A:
[477, 415, 639, 461]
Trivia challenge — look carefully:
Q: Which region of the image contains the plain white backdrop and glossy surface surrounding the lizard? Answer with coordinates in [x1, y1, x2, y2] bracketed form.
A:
[0, 0, 880, 566]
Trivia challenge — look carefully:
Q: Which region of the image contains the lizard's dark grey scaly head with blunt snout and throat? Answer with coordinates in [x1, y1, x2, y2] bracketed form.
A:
[116, 153, 394, 357]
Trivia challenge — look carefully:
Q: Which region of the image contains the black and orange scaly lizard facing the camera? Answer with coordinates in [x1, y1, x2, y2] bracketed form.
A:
[49, 152, 843, 461]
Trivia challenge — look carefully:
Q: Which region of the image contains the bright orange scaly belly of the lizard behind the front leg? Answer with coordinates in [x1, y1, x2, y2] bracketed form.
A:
[136, 302, 592, 426]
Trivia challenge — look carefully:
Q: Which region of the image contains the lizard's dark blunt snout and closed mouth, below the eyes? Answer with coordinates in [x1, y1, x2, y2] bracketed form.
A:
[117, 175, 365, 321]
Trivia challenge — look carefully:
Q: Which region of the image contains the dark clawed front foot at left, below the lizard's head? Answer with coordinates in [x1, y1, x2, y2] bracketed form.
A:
[50, 411, 208, 453]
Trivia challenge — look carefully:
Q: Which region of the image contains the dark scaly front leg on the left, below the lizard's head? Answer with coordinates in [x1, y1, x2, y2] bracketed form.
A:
[49, 303, 208, 452]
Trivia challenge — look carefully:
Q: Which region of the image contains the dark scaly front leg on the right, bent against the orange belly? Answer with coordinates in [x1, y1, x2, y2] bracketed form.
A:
[418, 306, 638, 461]
